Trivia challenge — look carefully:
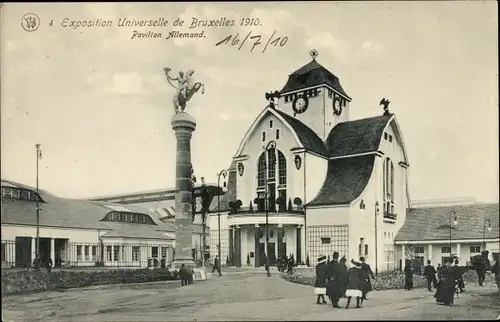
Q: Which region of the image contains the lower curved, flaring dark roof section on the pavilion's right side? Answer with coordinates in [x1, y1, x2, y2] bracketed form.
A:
[308, 154, 375, 206]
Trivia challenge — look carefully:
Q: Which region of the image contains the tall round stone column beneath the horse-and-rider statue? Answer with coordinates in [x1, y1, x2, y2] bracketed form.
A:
[172, 113, 196, 268]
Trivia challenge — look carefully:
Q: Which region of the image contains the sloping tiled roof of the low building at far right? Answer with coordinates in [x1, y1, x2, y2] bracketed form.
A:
[394, 203, 500, 241]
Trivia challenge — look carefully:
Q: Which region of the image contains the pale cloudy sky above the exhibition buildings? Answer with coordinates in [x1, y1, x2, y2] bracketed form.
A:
[0, 1, 499, 202]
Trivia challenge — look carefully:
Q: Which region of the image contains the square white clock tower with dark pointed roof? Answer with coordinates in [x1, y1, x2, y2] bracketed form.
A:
[279, 50, 351, 140]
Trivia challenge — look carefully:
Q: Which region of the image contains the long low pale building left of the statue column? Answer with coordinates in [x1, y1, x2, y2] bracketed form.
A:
[1, 179, 209, 267]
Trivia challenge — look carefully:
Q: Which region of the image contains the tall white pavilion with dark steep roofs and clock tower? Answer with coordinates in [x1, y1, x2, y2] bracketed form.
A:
[205, 51, 409, 268]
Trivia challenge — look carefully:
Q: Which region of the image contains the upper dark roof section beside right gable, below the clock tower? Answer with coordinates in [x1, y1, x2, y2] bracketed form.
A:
[325, 115, 392, 157]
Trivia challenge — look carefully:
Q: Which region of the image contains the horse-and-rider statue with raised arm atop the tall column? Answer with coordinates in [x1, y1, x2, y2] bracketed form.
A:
[163, 67, 205, 114]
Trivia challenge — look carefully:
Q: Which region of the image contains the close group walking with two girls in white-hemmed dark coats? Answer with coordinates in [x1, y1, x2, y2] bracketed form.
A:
[314, 252, 375, 309]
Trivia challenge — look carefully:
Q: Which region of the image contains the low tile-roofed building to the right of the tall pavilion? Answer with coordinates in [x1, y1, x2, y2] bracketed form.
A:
[394, 204, 500, 268]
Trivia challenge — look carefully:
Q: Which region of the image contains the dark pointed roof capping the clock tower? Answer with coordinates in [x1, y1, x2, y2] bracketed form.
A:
[281, 59, 350, 99]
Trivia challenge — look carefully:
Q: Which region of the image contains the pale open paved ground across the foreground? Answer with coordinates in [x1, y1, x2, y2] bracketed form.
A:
[2, 271, 500, 322]
